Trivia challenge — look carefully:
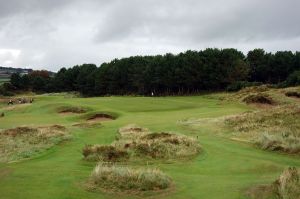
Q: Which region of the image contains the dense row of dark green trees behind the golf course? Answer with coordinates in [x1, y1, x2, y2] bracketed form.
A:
[4, 49, 300, 96]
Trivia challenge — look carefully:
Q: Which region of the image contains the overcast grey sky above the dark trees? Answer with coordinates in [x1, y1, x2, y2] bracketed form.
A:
[0, 0, 300, 71]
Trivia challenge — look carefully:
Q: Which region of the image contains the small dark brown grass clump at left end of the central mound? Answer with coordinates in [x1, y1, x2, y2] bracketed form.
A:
[82, 145, 129, 162]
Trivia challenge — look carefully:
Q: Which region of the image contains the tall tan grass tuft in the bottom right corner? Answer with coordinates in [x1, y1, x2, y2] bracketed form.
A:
[247, 168, 300, 199]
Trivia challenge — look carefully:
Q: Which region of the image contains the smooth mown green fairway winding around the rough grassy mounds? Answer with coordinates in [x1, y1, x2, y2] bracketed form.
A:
[0, 95, 300, 199]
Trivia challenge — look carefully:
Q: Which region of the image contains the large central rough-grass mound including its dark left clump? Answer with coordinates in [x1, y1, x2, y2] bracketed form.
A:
[82, 125, 201, 162]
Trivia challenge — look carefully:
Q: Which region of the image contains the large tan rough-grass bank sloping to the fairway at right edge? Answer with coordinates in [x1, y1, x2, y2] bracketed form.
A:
[225, 105, 300, 154]
